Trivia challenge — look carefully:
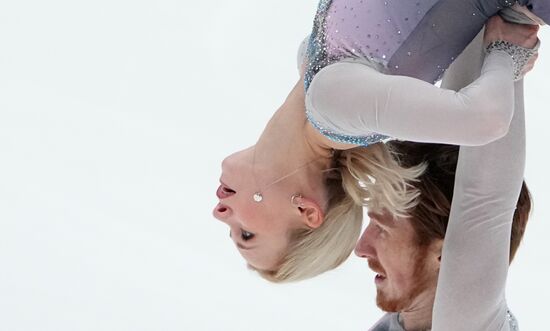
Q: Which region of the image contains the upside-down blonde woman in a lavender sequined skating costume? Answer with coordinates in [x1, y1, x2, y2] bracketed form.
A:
[214, 0, 536, 281]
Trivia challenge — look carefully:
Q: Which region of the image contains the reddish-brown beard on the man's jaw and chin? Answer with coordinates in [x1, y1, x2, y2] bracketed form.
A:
[376, 247, 432, 312]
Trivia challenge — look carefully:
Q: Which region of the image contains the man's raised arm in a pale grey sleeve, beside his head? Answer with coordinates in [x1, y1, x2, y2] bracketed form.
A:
[432, 31, 525, 331]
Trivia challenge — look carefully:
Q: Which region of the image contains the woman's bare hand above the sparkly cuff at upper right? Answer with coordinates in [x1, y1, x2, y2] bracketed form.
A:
[483, 15, 539, 48]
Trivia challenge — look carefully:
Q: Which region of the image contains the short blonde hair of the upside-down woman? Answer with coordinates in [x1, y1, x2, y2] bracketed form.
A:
[249, 143, 425, 283]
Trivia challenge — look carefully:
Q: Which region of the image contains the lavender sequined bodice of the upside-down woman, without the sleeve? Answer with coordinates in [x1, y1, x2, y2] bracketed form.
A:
[305, 0, 515, 89]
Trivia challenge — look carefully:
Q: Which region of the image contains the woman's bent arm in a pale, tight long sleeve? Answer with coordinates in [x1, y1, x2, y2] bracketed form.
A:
[306, 52, 514, 146]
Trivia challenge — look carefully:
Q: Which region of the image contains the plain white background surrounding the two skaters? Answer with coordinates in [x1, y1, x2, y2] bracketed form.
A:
[0, 0, 550, 331]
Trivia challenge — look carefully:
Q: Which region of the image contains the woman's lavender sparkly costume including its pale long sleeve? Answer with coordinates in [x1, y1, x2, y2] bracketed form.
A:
[304, 0, 550, 146]
